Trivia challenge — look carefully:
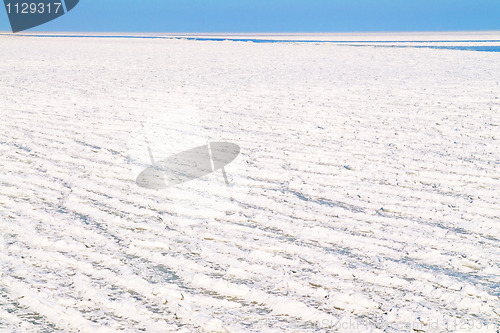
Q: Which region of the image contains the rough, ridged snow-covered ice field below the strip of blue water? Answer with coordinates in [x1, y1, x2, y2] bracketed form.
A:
[0, 33, 500, 332]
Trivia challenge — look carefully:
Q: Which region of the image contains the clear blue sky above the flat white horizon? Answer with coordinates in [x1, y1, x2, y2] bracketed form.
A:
[0, 0, 500, 32]
